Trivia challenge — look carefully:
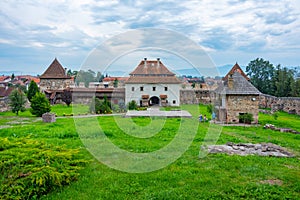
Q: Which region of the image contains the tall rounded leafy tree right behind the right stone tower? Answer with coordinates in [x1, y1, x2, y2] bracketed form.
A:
[246, 58, 275, 95]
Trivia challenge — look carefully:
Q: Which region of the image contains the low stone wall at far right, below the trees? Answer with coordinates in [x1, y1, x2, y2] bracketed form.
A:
[259, 94, 300, 115]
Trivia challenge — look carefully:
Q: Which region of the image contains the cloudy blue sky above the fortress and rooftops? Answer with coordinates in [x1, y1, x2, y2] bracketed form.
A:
[0, 0, 300, 75]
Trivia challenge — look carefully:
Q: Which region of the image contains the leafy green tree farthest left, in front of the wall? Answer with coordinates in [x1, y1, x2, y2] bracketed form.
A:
[9, 89, 26, 115]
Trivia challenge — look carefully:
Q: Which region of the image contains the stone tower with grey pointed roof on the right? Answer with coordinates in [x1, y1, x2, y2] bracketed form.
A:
[215, 63, 260, 123]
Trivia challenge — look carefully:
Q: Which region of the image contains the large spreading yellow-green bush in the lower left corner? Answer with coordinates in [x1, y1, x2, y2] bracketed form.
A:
[0, 138, 88, 199]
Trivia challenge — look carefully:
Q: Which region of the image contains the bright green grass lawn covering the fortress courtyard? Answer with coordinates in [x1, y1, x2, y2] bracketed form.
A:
[0, 105, 300, 199]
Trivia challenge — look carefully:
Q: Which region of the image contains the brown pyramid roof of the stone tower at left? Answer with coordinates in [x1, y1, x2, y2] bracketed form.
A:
[40, 58, 71, 79]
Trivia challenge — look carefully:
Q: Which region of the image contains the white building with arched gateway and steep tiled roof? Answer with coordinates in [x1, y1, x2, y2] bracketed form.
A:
[125, 58, 181, 106]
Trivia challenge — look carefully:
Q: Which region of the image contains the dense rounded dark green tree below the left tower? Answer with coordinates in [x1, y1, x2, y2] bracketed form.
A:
[30, 92, 51, 117]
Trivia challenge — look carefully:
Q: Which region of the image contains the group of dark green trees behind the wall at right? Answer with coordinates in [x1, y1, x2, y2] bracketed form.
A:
[246, 58, 300, 97]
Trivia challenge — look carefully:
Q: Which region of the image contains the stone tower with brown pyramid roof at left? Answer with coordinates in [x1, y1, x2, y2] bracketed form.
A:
[40, 58, 74, 91]
